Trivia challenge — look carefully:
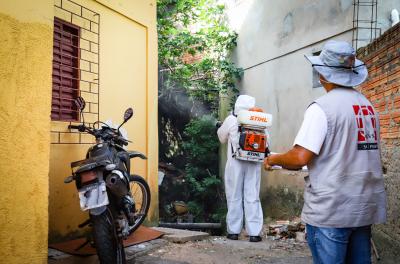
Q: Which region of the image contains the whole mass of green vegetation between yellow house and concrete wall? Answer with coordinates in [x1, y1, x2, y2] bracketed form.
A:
[157, 0, 242, 221]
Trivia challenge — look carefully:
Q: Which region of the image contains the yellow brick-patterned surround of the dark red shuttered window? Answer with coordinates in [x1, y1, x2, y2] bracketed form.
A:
[51, 0, 100, 144]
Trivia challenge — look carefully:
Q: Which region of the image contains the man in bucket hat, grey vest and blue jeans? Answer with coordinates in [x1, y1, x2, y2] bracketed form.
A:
[264, 41, 386, 264]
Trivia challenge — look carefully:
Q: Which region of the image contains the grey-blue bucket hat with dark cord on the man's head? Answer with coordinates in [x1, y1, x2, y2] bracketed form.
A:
[305, 40, 368, 87]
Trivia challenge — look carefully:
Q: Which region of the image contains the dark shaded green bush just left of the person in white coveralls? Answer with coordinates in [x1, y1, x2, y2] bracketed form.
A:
[183, 116, 225, 221]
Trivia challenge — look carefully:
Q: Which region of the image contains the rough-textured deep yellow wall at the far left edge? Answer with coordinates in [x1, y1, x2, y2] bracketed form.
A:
[0, 0, 53, 263]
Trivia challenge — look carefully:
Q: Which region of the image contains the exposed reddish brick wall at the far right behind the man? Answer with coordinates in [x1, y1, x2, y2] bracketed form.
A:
[358, 24, 400, 263]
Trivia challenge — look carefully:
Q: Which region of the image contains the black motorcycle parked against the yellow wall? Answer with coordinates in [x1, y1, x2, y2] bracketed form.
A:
[64, 97, 151, 264]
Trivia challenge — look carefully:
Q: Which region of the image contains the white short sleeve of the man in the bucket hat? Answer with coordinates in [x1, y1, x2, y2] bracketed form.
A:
[293, 103, 328, 155]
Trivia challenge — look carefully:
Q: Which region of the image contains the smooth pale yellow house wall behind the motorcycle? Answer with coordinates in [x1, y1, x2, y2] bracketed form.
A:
[49, 0, 158, 241]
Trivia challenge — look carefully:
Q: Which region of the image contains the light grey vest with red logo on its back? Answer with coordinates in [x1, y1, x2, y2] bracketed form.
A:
[302, 88, 386, 227]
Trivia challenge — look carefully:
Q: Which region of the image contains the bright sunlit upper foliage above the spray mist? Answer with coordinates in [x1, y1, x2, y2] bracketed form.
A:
[157, 0, 242, 109]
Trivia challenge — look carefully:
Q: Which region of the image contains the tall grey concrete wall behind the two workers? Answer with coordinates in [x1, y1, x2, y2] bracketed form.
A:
[227, 0, 400, 219]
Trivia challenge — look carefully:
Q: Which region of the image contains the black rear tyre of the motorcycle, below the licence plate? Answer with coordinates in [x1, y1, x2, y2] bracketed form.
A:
[90, 209, 126, 264]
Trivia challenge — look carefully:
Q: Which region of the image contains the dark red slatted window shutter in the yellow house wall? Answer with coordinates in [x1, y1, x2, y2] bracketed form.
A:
[51, 18, 80, 121]
